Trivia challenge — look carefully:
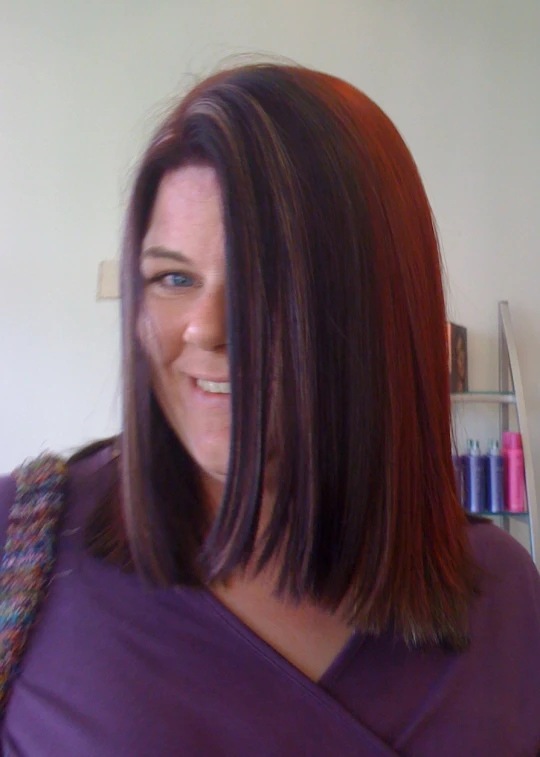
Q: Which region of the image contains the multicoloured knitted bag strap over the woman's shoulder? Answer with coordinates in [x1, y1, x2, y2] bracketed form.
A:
[0, 455, 66, 719]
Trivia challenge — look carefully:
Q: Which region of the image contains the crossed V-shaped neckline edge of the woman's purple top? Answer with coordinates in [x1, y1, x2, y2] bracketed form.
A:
[200, 589, 365, 691]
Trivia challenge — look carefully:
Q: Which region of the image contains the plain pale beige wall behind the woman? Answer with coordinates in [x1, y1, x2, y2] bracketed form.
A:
[0, 0, 540, 502]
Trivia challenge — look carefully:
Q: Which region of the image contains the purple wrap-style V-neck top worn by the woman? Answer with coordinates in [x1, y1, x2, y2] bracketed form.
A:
[0, 450, 540, 757]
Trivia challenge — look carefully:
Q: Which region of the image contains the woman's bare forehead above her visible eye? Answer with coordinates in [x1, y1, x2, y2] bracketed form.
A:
[144, 166, 223, 248]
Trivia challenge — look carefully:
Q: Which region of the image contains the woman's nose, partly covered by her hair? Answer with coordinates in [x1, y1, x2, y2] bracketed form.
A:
[184, 286, 227, 352]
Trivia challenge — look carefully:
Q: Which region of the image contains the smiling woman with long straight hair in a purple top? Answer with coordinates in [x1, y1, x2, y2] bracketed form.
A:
[0, 64, 540, 757]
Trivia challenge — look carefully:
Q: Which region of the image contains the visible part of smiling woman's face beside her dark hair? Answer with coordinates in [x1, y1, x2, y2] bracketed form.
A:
[139, 166, 231, 482]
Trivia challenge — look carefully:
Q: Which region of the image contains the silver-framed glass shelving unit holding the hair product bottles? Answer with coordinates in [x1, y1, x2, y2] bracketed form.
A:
[451, 302, 540, 566]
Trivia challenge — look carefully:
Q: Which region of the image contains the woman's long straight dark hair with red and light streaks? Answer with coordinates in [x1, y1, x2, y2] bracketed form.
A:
[86, 64, 475, 648]
